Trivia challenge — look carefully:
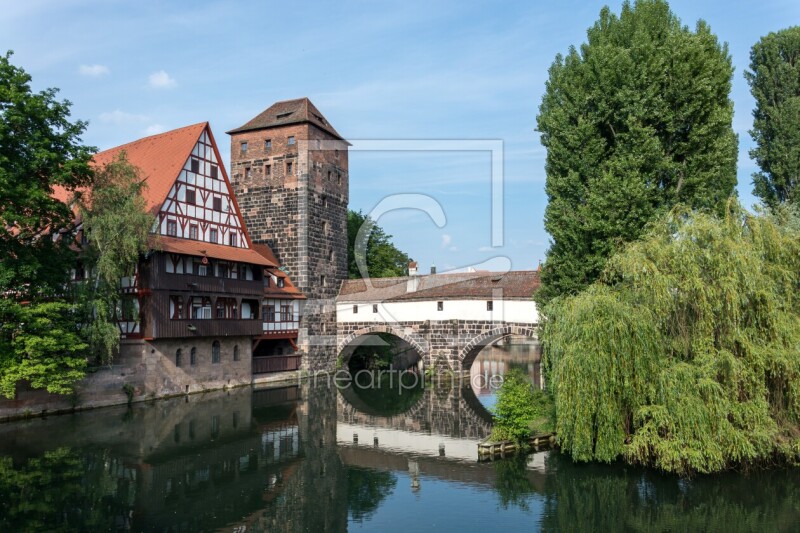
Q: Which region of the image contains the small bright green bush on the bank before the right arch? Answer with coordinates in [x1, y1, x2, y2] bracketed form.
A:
[492, 369, 553, 443]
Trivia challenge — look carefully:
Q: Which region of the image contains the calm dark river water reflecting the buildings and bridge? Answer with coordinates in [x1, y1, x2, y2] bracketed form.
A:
[0, 347, 800, 532]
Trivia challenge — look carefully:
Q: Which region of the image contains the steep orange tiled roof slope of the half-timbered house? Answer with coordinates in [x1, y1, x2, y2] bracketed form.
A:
[92, 122, 208, 212]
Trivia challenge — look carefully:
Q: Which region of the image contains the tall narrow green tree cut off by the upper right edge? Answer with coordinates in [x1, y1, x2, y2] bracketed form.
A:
[744, 26, 800, 207]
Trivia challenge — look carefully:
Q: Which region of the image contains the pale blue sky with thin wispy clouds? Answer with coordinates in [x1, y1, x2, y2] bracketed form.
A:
[0, 0, 800, 272]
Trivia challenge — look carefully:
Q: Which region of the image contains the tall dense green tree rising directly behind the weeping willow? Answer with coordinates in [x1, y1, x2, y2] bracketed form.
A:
[536, 0, 737, 304]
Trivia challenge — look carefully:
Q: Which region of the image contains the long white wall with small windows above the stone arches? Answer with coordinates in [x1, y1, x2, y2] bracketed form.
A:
[336, 300, 539, 323]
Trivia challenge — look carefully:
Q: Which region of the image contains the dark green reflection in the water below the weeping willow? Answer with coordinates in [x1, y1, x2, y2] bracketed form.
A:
[541, 454, 800, 533]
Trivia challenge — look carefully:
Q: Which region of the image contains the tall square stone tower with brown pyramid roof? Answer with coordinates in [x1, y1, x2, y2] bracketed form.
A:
[228, 98, 349, 371]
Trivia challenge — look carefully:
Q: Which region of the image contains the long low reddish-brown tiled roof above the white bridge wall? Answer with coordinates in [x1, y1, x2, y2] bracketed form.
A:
[336, 270, 539, 302]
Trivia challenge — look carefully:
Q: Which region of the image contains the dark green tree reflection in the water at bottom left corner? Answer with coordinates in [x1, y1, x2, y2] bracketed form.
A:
[0, 448, 127, 531]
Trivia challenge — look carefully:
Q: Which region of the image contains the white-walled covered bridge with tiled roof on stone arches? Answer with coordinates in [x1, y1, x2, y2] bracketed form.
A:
[336, 271, 539, 371]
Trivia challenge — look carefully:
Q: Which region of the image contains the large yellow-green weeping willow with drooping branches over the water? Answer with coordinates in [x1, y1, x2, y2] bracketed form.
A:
[543, 203, 800, 474]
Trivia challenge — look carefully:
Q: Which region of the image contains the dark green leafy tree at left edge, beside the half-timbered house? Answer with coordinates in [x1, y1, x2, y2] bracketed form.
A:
[0, 52, 94, 297]
